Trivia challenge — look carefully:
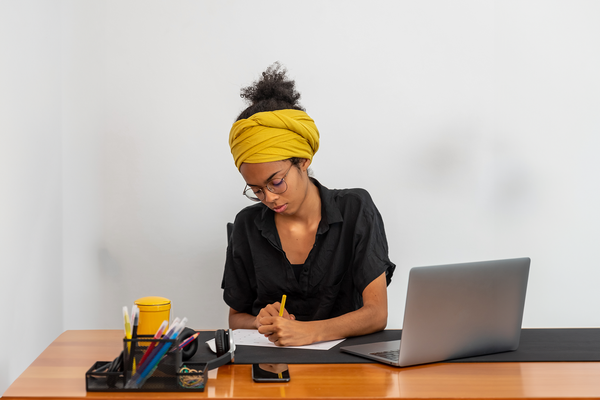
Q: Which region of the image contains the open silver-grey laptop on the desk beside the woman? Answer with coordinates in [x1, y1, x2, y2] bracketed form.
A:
[341, 258, 531, 367]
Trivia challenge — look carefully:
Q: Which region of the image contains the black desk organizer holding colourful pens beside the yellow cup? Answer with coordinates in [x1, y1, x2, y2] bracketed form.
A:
[85, 335, 208, 392]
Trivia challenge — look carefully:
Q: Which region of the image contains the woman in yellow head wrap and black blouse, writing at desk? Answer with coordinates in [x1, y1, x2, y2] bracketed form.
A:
[222, 63, 395, 346]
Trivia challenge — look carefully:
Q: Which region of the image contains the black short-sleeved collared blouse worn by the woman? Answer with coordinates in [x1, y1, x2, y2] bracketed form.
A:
[221, 179, 396, 321]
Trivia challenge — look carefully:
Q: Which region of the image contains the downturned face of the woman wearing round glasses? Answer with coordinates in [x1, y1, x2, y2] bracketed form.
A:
[240, 159, 310, 215]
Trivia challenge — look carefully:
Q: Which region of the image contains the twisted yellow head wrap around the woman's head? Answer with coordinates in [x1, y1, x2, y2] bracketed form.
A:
[229, 110, 319, 170]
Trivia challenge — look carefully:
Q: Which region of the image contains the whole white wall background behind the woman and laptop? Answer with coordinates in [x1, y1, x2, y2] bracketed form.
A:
[0, 1, 600, 392]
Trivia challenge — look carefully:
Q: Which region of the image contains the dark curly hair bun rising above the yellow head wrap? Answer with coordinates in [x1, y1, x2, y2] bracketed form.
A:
[238, 62, 306, 120]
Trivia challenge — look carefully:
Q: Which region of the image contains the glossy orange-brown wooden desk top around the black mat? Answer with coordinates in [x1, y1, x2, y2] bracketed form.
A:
[2, 330, 600, 400]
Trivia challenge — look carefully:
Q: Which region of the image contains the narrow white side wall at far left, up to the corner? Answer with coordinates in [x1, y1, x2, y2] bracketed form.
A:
[0, 1, 63, 393]
